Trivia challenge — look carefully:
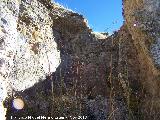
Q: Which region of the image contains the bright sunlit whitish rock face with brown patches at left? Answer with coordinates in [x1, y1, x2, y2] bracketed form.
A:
[0, 0, 60, 119]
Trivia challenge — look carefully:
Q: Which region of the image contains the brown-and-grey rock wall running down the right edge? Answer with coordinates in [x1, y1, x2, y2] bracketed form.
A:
[123, 0, 160, 119]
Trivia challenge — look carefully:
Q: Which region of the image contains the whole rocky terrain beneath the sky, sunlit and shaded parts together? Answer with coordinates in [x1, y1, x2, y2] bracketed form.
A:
[0, 0, 160, 120]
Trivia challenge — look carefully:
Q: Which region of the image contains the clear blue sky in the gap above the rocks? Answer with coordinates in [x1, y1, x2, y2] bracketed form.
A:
[55, 0, 123, 33]
